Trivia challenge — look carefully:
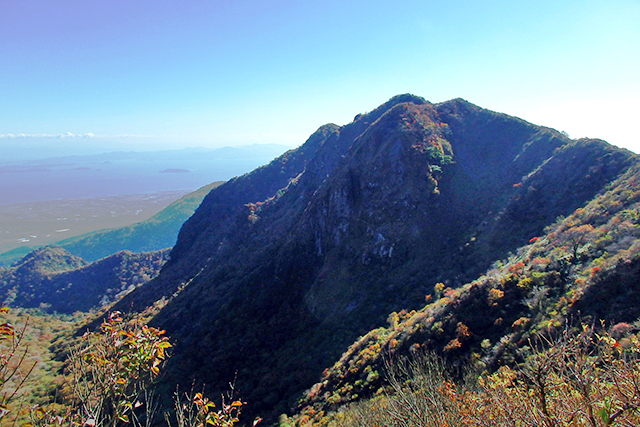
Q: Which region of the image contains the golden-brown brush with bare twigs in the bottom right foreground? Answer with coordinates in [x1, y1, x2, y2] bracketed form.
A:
[306, 326, 640, 427]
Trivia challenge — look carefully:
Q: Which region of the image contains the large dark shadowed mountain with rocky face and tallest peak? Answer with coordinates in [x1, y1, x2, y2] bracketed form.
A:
[112, 95, 637, 422]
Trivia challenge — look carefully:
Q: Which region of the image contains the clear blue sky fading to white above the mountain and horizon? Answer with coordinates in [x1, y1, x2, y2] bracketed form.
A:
[0, 0, 640, 152]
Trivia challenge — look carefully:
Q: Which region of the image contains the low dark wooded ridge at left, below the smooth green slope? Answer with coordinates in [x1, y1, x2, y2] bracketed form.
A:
[0, 246, 169, 314]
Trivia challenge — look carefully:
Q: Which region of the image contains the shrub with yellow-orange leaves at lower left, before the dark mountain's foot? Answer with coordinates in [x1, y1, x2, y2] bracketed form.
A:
[30, 312, 260, 427]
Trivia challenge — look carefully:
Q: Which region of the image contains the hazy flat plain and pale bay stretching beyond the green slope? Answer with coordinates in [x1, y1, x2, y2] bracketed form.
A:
[0, 144, 288, 253]
